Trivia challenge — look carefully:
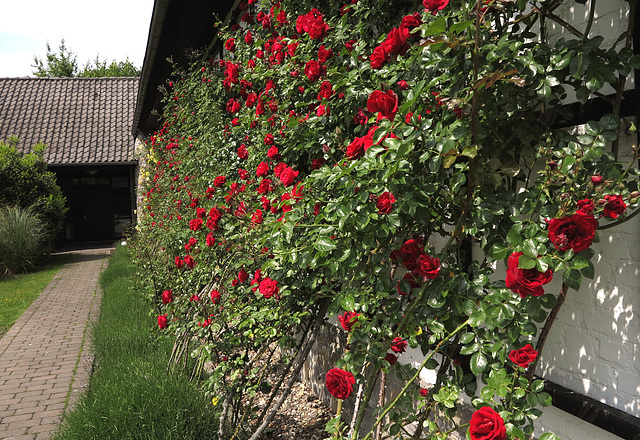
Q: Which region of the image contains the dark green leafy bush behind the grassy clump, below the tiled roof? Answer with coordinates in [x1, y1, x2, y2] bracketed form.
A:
[0, 139, 67, 245]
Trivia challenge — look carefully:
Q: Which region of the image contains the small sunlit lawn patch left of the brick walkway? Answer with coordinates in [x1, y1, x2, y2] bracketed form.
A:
[0, 254, 73, 337]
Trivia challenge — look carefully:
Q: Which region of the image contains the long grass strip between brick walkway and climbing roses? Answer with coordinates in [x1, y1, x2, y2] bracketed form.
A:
[54, 247, 218, 440]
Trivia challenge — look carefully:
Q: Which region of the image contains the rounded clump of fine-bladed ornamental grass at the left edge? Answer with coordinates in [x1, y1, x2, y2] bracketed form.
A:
[0, 206, 47, 273]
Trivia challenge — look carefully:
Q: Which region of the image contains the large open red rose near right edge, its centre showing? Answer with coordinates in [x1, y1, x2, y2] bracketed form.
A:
[549, 214, 598, 252]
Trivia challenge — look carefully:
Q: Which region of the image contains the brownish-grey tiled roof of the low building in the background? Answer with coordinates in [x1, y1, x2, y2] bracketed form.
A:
[0, 78, 138, 164]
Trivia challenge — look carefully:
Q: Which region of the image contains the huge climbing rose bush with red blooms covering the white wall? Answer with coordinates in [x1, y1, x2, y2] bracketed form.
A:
[133, 0, 640, 440]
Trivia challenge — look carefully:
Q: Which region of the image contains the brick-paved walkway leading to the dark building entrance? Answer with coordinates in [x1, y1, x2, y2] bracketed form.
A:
[0, 248, 111, 440]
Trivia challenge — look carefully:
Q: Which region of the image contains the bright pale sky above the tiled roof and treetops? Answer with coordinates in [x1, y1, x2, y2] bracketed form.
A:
[0, 0, 153, 78]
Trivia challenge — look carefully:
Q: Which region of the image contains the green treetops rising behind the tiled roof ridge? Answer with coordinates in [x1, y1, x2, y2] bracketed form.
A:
[32, 38, 140, 78]
